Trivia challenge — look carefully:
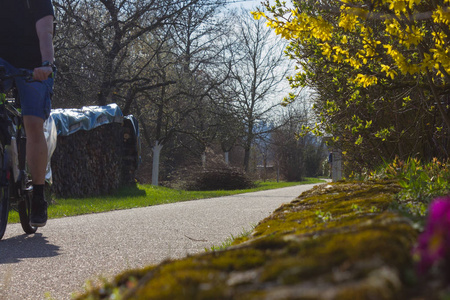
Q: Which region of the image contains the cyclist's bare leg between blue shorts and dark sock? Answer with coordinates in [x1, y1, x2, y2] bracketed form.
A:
[23, 116, 47, 185]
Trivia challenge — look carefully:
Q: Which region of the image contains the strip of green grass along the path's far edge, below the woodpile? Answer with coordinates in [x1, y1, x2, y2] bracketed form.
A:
[8, 178, 323, 223]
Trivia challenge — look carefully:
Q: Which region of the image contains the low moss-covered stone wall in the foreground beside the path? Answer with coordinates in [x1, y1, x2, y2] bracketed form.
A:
[78, 182, 428, 300]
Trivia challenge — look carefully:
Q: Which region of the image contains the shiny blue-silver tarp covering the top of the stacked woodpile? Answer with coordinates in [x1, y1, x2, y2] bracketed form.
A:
[50, 103, 124, 136]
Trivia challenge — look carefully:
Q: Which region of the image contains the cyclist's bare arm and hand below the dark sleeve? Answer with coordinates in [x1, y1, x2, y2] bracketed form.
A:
[33, 15, 55, 80]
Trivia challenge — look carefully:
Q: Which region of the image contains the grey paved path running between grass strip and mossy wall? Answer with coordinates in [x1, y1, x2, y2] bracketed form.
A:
[0, 185, 324, 300]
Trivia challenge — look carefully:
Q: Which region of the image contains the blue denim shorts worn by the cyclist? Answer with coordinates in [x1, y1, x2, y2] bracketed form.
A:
[0, 58, 53, 120]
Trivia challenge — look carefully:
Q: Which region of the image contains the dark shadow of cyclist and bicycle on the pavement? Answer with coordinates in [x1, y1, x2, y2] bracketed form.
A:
[0, 233, 60, 264]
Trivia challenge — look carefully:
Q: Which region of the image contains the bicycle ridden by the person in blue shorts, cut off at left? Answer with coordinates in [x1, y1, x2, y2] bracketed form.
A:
[0, 66, 43, 239]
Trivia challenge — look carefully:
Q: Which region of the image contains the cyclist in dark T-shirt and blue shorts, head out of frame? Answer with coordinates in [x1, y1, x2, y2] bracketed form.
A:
[0, 0, 55, 227]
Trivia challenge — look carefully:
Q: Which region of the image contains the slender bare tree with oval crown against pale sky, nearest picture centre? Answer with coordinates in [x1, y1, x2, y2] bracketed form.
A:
[228, 10, 289, 171]
